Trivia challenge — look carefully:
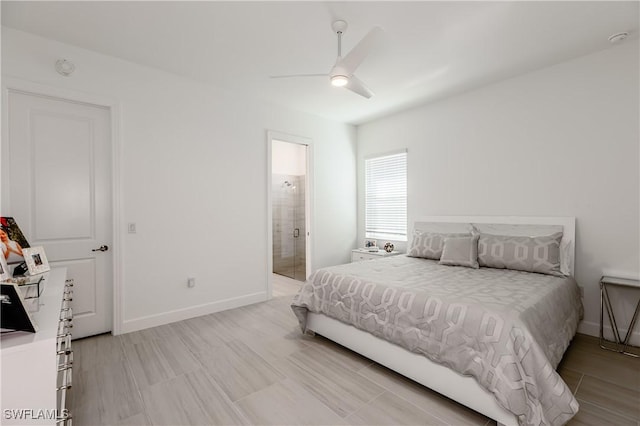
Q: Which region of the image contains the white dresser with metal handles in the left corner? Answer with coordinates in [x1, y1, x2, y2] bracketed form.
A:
[0, 268, 73, 425]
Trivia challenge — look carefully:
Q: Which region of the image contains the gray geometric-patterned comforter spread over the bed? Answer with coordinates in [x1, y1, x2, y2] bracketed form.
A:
[292, 256, 582, 425]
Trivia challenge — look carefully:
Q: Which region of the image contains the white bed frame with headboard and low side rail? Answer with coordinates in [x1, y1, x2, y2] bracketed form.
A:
[307, 216, 575, 426]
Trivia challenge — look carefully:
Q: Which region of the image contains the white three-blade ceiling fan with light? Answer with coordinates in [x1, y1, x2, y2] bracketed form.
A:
[271, 20, 383, 99]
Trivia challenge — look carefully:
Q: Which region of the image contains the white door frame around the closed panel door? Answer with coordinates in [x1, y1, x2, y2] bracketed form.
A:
[0, 77, 124, 335]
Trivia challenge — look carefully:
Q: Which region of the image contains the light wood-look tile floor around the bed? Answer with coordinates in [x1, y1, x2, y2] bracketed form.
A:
[69, 276, 640, 426]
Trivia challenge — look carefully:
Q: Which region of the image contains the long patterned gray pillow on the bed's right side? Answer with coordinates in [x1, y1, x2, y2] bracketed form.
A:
[478, 232, 563, 277]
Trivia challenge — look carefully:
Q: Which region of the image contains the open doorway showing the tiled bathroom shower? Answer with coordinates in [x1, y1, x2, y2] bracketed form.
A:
[270, 137, 310, 281]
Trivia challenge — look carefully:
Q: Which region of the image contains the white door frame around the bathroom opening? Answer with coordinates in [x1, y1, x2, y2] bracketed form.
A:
[265, 130, 315, 299]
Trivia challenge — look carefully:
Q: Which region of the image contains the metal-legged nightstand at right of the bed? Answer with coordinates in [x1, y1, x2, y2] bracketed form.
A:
[600, 276, 640, 357]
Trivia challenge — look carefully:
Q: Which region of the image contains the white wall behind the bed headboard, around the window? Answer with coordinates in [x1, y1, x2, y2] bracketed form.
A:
[358, 40, 640, 342]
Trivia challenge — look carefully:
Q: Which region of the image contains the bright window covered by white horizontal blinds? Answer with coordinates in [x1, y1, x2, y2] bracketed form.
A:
[364, 151, 407, 241]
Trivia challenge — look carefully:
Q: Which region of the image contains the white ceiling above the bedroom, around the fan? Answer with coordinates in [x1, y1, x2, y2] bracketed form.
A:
[2, 0, 640, 124]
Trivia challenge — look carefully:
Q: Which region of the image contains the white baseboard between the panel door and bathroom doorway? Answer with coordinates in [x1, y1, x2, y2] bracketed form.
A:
[120, 291, 267, 334]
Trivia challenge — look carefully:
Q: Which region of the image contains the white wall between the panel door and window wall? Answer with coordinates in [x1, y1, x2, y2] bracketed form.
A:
[2, 28, 356, 332]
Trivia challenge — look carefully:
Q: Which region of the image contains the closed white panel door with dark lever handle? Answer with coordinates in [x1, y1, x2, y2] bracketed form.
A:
[2, 90, 113, 338]
